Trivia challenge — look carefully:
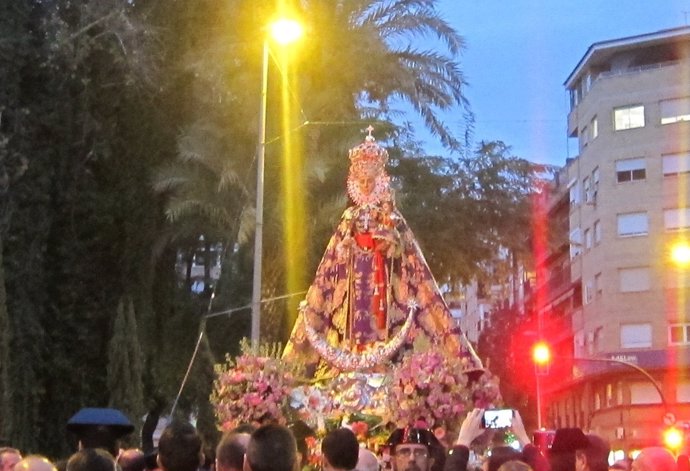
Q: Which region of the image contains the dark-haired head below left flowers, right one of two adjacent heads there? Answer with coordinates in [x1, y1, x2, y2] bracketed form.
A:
[244, 424, 298, 471]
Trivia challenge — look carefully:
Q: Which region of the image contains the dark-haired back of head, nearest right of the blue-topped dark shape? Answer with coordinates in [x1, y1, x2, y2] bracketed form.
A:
[158, 420, 204, 471]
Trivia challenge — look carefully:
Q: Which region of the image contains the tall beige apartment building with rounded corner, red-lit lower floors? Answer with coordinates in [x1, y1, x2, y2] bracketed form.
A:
[538, 27, 690, 451]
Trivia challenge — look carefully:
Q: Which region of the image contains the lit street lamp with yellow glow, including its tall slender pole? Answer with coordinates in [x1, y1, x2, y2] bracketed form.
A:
[251, 18, 302, 346]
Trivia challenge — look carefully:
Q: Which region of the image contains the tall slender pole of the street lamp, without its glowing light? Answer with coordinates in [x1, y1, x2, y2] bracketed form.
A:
[252, 39, 268, 347]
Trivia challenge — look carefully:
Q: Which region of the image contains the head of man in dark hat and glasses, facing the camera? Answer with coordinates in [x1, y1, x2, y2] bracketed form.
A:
[387, 427, 438, 471]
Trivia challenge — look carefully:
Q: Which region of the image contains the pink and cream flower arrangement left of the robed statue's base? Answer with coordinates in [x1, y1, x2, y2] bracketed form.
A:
[210, 339, 298, 431]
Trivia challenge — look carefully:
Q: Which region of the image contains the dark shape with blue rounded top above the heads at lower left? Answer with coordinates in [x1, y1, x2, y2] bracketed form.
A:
[67, 407, 134, 457]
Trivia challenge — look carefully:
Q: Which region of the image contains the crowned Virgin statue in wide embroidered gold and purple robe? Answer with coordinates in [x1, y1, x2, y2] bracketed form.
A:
[283, 127, 482, 378]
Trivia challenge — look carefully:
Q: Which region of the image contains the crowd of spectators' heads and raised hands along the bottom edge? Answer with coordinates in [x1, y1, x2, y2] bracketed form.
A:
[0, 409, 690, 471]
